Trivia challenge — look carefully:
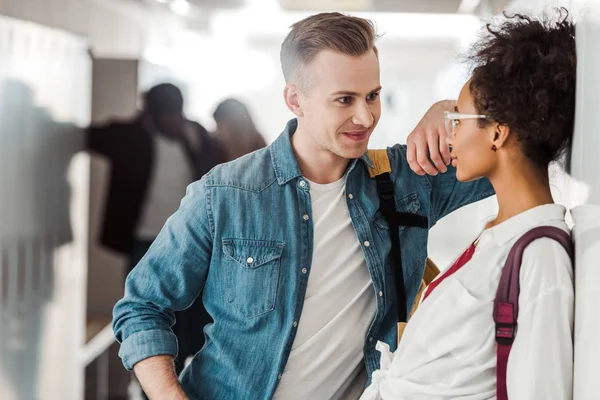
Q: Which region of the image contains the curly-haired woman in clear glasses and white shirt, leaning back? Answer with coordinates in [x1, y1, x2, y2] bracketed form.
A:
[362, 10, 576, 400]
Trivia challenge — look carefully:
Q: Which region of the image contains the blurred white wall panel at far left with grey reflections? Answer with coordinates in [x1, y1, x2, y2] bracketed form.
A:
[0, 17, 91, 400]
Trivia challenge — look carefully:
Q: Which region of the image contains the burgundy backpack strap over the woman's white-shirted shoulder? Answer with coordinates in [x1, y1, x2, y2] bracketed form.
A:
[494, 226, 573, 400]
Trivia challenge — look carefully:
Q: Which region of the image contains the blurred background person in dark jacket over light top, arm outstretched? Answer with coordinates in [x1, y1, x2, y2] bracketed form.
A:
[88, 83, 224, 380]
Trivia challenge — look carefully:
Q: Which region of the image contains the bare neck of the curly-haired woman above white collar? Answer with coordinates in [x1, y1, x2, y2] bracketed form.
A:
[487, 165, 554, 228]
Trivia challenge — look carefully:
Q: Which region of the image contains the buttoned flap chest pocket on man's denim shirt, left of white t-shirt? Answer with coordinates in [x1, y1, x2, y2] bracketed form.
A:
[223, 239, 285, 318]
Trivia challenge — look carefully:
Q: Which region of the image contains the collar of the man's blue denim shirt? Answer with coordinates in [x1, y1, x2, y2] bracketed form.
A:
[269, 118, 373, 185]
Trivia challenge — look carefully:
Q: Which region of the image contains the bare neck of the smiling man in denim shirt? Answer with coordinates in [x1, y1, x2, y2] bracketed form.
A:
[292, 127, 350, 184]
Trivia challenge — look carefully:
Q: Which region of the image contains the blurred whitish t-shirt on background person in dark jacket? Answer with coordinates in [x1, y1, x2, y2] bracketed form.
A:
[136, 134, 193, 240]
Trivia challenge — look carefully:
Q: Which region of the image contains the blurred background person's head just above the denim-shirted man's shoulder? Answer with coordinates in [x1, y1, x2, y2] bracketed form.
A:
[213, 99, 267, 161]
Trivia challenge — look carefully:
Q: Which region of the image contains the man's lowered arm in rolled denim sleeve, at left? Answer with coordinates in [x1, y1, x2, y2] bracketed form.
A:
[113, 179, 213, 399]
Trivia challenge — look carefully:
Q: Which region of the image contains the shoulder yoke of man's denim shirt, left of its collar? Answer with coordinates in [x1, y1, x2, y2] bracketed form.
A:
[205, 147, 277, 192]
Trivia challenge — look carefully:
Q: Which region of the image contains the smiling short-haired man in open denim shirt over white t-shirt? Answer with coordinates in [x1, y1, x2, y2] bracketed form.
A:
[114, 13, 493, 399]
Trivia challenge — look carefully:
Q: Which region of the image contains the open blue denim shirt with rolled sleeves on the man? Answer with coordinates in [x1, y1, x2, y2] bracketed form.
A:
[113, 120, 494, 400]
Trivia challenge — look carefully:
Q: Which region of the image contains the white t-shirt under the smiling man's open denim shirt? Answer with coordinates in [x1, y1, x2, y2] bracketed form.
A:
[275, 177, 376, 400]
